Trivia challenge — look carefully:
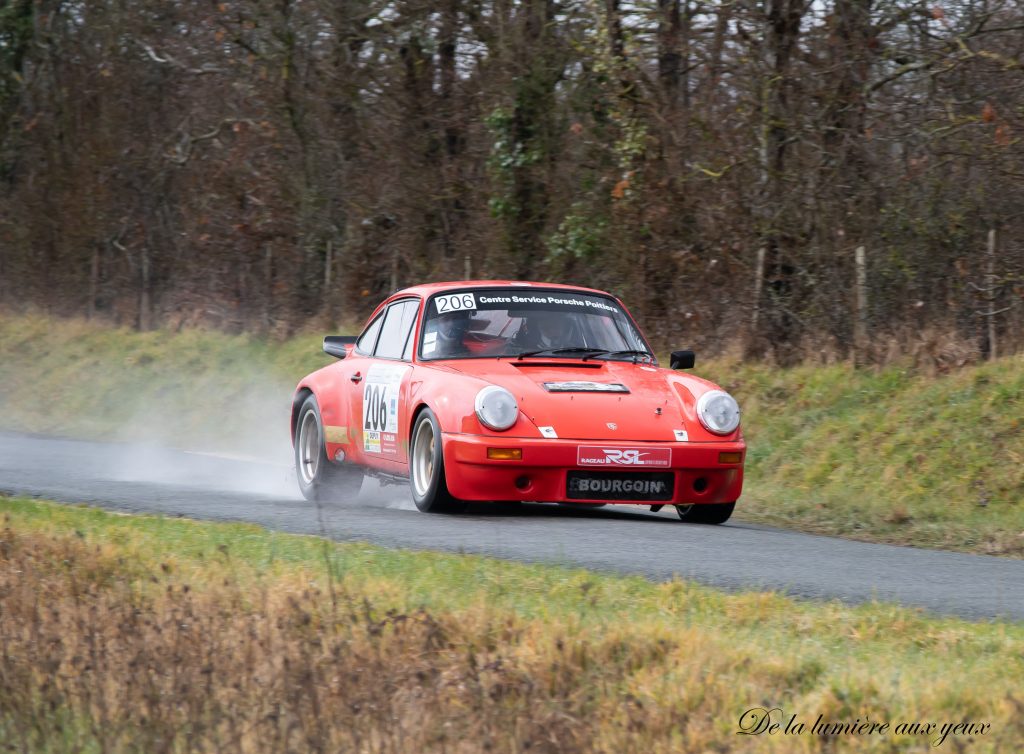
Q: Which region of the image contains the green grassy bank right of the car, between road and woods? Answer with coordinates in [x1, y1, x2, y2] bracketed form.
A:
[707, 355, 1024, 557]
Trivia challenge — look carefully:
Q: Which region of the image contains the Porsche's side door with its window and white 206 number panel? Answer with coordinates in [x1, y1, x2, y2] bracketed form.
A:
[349, 298, 420, 472]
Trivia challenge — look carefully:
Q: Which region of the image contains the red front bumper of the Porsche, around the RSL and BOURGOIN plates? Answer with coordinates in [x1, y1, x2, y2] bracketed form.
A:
[441, 433, 746, 505]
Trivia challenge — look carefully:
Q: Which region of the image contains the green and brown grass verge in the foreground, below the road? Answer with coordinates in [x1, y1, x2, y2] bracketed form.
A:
[0, 498, 1024, 754]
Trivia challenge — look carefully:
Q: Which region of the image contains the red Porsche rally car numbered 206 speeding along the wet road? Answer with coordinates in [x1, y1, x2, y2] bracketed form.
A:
[292, 281, 745, 523]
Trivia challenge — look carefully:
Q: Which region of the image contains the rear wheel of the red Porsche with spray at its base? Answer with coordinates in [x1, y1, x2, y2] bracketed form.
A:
[294, 395, 362, 503]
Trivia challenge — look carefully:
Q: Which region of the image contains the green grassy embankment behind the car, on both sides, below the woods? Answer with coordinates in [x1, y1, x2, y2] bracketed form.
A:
[0, 317, 1024, 557]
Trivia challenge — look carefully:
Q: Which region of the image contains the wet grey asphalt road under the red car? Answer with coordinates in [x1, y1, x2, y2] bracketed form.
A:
[0, 433, 1024, 620]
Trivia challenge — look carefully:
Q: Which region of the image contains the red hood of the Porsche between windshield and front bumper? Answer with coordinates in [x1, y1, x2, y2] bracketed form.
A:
[445, 359, 738, 443]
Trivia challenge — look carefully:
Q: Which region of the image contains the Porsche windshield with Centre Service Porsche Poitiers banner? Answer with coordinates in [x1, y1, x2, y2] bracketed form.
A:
[420, 288, 653, 361]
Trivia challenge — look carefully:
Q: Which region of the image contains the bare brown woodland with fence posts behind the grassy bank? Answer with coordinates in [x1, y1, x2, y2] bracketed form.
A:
[0, 0, 1024, 366]
